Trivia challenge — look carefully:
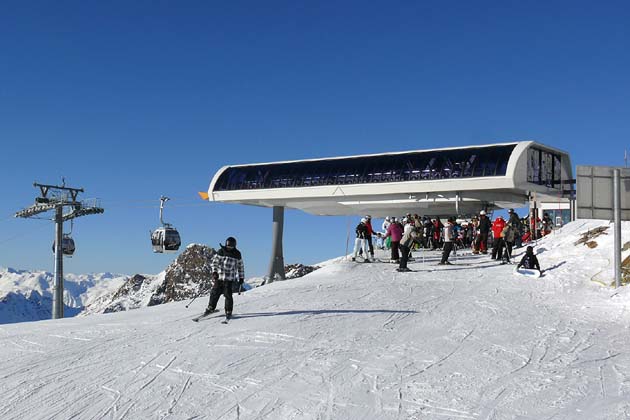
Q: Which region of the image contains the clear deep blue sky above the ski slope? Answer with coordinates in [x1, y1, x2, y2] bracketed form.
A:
[0, 1, 630, 275]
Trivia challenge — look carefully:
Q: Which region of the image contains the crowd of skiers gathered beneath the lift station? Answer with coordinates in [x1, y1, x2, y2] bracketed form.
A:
[352, 209, 553, 271]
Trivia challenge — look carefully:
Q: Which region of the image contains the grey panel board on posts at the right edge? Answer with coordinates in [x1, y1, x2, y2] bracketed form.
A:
[576, 166, 630, 220]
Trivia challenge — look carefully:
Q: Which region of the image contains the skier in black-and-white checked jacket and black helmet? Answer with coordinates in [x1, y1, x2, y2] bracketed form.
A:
[204, 236, 245, 318]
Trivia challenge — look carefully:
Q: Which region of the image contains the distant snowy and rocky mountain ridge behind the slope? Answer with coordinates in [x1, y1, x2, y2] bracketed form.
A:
[0, 244, 319, 324]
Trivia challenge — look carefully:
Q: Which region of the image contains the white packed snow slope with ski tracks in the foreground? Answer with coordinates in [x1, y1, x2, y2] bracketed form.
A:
[0, 221, 630, 420]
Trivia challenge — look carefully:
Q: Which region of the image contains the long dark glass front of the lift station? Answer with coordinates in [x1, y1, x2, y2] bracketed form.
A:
[214, 144, 516, 191]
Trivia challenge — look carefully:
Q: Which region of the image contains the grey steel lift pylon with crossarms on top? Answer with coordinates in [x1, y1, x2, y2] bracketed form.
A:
[15, 182, 105, 319]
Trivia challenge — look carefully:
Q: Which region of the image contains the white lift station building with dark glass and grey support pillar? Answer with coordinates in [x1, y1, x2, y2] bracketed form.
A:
[203, 141, 573, 281]
